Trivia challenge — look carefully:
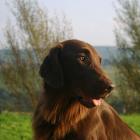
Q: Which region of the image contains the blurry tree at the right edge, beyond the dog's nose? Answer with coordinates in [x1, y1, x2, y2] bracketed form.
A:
[115, 0, 140, 112]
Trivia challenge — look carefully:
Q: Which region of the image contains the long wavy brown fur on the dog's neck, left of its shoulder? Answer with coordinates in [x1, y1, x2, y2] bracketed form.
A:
[33, 83, 89, 140]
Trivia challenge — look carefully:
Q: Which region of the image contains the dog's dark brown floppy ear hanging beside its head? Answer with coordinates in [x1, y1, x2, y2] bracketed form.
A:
[39, 44, 64, 88]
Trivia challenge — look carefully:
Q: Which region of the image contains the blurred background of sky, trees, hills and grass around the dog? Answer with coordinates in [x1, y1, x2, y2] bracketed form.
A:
[0, 0, 140, 140]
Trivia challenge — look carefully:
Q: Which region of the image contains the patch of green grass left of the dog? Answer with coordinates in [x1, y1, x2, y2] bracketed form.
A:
[0, 112, 32, 140]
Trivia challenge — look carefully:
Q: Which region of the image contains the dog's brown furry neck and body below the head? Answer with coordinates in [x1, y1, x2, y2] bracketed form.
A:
[33, 83, 140, 140]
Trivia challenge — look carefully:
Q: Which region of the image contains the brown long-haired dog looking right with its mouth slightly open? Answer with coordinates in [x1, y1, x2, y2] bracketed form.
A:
[33, 40, 140, 140]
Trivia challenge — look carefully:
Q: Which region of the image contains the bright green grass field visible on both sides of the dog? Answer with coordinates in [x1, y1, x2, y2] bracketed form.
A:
[0, 112, 140, 140]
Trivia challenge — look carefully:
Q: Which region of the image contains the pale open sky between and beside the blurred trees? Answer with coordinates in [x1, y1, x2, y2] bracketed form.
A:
[0, 0, 116, 46]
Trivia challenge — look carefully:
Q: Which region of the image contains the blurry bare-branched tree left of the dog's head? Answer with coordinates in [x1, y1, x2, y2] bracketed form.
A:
[1, 0, 72, 110]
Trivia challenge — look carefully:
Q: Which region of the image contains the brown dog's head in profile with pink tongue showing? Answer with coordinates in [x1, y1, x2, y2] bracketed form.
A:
[40, 40, 114, 107]
